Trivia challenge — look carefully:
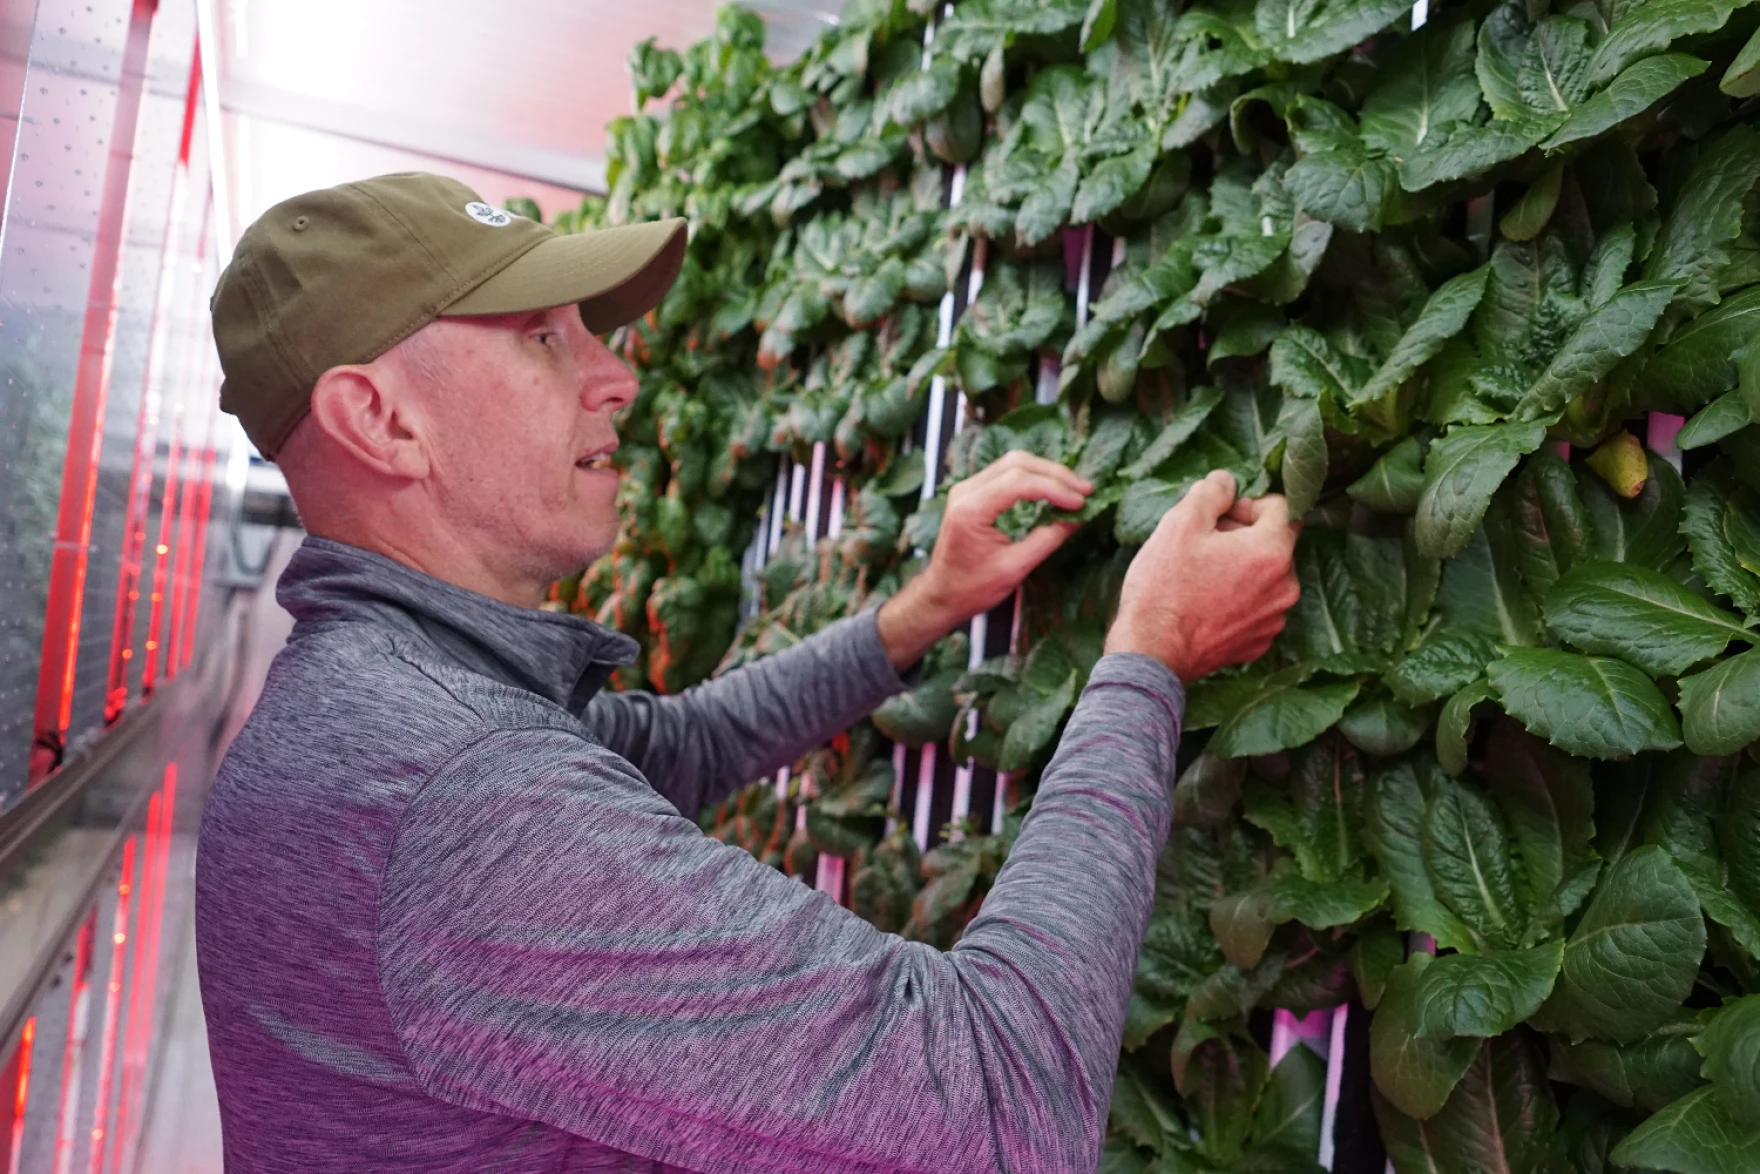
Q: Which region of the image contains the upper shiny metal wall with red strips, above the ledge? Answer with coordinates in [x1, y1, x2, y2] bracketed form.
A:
[0, 0, 232, 811]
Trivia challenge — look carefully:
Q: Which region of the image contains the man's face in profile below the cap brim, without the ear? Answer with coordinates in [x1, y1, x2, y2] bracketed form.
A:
[412, 306, 637, 583]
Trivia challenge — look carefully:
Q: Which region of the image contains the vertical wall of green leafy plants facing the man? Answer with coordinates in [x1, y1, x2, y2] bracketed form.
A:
[528, 0, 1760, 1174]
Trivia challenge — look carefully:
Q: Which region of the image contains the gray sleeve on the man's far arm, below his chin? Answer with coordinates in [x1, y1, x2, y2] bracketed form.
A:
[581, 609, 905, 818]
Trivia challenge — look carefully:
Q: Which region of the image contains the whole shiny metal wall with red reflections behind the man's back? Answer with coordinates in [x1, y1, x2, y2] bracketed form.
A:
[0, 0, 243, 1174]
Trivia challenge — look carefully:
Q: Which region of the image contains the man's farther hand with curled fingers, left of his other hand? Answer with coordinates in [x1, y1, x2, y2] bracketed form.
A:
[875, 452, 1093, 671]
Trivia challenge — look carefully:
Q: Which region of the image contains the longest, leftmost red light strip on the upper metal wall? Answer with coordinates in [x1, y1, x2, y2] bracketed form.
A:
[30, 0, 157, 783]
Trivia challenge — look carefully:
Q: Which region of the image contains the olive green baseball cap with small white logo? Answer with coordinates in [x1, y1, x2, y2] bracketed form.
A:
[209, 172, 686, 458]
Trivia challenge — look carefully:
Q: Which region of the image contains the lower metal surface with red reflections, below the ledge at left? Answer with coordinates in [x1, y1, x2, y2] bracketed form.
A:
[0, 633, 236, 1174]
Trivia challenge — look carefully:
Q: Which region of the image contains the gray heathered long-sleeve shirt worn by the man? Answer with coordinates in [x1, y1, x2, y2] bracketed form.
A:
[197, 539, 1183, 1174]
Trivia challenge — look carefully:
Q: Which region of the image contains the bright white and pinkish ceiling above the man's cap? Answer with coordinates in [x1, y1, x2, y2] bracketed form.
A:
[216, 0, 840, 235]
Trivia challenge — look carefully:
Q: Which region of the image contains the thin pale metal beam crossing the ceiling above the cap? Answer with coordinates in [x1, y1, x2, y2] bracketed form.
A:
[220, 77, 605, 192]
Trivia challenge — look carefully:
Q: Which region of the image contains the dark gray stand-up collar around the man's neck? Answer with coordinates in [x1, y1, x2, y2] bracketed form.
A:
[275, 537, 641, 713]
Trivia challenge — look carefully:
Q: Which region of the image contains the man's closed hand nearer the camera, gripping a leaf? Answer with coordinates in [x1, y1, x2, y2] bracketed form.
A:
[1105, 470, 1301, 681]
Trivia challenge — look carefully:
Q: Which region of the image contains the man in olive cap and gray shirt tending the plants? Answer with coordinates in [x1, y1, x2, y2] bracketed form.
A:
[197, 174, 1295, 1172]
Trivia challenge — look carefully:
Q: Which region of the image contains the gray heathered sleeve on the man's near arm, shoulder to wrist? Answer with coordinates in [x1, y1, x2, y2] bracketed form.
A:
[378, 655, 1183, 1174]
